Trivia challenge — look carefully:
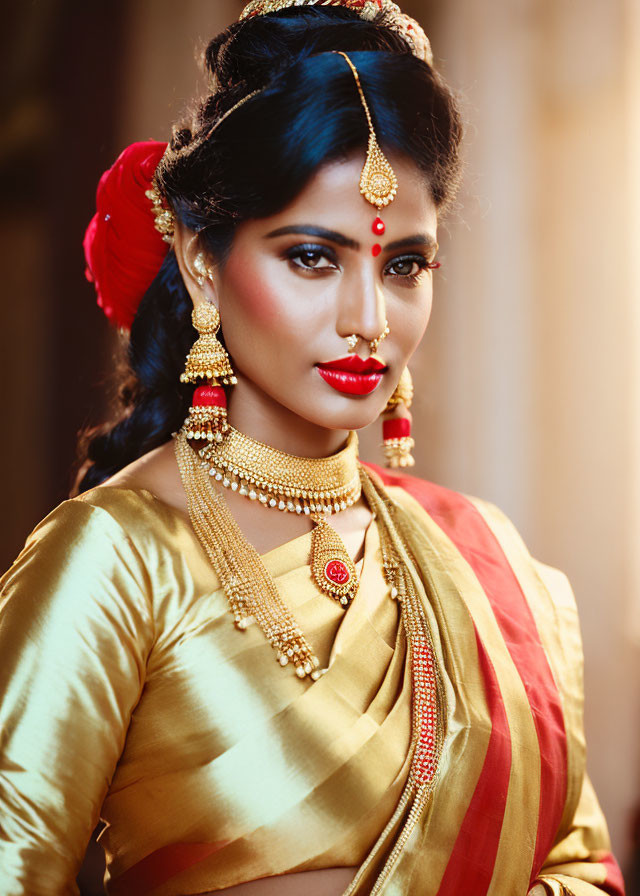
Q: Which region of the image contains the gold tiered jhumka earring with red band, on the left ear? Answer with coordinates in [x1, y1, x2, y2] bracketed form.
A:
[180, 253, 237, 442]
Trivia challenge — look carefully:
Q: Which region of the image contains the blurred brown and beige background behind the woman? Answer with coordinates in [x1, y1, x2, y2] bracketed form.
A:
[0, 0, 640, 894]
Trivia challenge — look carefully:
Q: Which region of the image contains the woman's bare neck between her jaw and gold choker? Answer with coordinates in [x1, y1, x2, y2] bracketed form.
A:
[229, 378, 349, 457]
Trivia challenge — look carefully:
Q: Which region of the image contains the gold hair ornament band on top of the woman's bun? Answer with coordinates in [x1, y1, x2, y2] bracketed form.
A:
[240, 0, 433, 65]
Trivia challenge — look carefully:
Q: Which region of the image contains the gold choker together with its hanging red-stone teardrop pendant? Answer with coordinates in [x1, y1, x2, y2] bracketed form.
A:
[198, 426, 362, 609]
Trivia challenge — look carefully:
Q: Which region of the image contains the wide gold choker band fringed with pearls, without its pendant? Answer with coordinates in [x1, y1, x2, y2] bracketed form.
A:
[198, 426, 361, 516]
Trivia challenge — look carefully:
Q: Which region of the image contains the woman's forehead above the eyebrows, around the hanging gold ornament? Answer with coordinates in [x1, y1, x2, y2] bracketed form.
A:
[246, 152, 437, 237]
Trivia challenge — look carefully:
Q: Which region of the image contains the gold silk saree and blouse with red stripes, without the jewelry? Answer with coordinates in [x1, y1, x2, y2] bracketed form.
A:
[0, 471, 623, 896]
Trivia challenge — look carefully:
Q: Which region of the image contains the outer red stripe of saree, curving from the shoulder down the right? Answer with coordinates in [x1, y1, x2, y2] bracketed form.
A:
[366, 464, 568, 882]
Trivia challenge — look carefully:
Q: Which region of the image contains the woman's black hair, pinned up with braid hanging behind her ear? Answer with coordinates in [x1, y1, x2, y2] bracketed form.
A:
[79, 6, 462, 491]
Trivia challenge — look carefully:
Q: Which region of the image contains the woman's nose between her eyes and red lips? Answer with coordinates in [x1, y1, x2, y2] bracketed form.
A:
[336, 263, 386, 354]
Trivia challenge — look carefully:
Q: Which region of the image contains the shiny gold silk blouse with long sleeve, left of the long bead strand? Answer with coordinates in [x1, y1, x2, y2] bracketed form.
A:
[0, 487, 410, 896]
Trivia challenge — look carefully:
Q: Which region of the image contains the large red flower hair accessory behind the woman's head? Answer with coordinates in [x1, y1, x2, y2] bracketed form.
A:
[83, 140, 168, 330]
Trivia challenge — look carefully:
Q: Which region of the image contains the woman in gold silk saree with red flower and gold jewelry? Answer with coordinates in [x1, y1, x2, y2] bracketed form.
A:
[0, 0, 623, 896]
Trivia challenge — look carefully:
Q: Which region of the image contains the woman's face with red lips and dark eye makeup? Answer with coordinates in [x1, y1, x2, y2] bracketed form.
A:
[213, 153, 437, 430]
